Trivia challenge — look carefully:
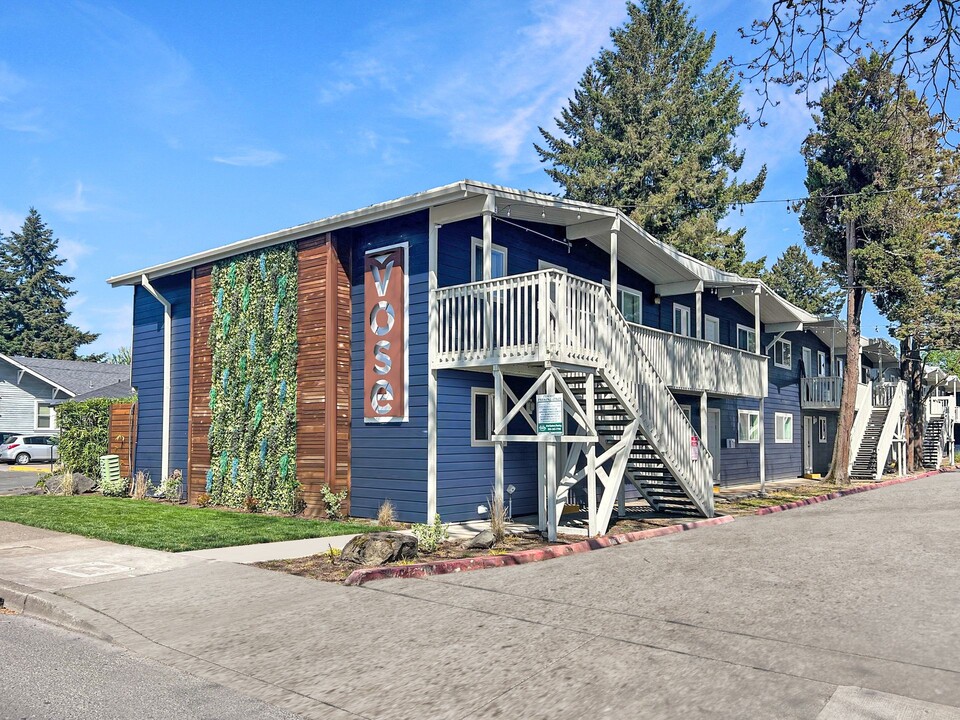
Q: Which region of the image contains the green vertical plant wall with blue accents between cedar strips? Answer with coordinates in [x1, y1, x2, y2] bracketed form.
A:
[207, 243, 300, 512]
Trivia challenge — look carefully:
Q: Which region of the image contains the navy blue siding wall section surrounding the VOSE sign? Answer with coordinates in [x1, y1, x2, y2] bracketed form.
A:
[343, 211, 429, 522]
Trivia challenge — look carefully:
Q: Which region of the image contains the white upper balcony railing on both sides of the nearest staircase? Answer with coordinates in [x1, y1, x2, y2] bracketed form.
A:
[432, 271, 767, 397]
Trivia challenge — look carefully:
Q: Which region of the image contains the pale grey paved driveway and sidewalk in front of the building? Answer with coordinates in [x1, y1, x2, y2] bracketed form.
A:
[0, 474, 960, 720]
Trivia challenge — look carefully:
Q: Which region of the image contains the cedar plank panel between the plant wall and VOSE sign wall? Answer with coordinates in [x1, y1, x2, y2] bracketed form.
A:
[297, 234, 351, 516]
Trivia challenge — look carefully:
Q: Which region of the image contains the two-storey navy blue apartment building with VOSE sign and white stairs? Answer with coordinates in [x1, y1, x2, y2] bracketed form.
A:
[101, 181, 912, 532]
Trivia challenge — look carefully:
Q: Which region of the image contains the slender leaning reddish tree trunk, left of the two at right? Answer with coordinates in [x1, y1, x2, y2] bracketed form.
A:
[827, 220, 865, 485]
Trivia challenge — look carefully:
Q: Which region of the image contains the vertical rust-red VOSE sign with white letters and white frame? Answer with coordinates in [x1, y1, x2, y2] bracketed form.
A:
[363, 244, 407, 422]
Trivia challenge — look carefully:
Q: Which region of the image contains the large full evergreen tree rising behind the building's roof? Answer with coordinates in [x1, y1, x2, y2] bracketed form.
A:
[535, 0, 766, 275]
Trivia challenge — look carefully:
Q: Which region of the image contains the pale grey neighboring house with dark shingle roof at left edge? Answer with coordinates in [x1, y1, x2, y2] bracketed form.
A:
[0, 354, 130, 432]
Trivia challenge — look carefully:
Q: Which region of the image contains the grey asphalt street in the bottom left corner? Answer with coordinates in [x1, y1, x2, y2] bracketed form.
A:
[0, 615, 296, 720]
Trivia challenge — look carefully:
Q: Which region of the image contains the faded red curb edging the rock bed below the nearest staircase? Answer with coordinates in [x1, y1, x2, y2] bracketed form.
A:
[344, 515, 733, 585]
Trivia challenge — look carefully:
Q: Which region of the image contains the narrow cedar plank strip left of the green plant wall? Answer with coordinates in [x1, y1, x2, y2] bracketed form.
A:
[187, 265, 213, 500]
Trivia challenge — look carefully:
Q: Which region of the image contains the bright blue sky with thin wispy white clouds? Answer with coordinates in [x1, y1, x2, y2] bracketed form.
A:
[0, 0, 884, 358]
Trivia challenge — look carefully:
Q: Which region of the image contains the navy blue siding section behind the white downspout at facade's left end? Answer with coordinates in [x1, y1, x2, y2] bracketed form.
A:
[131, 272, 191, 482]
